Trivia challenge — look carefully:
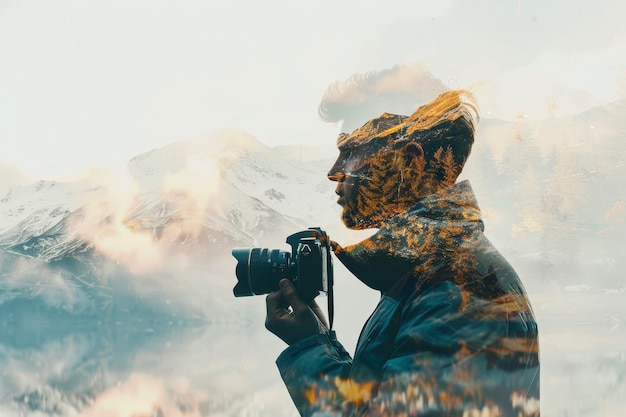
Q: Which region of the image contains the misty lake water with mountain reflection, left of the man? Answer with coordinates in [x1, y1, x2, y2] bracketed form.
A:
[0, 304, 290, 417]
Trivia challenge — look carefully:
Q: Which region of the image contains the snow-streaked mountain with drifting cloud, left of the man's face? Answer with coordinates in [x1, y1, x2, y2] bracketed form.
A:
[0, 129, 338, 324]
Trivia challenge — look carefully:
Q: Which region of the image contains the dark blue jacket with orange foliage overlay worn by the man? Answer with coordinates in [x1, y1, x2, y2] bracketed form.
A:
[277, 182, 539, 417]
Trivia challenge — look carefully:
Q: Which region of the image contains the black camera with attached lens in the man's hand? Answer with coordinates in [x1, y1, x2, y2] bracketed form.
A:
[232, 227, 333, 303]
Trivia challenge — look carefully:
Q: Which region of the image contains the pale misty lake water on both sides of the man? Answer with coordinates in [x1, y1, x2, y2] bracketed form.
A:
[0, 282, 626, 417]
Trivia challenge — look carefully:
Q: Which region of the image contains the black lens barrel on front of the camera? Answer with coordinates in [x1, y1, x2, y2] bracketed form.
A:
[232, 248, 291, 297]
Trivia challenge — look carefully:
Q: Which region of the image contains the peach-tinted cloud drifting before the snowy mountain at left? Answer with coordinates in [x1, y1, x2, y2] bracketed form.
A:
[71, 148, 221, 275]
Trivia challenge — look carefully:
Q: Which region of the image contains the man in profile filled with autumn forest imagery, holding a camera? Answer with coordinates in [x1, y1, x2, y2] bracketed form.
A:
[266, 91, 539, 417]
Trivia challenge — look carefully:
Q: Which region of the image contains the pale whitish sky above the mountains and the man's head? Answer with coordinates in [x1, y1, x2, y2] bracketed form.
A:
[0, 0, 626, 182]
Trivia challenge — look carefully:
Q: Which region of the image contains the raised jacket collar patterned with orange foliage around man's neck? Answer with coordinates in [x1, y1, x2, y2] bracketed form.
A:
[336, 181, 483, 293]
